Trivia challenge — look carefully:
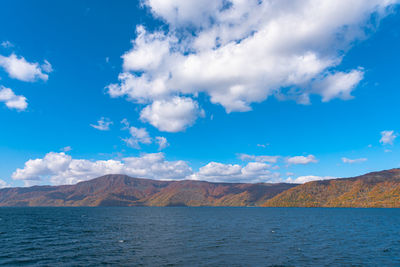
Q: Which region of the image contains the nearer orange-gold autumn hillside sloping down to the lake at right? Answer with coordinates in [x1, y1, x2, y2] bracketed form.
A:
[262, 169, 400, 208]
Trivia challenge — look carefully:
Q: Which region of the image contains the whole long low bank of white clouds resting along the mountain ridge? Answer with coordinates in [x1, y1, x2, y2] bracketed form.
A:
[12, 152, 280, 186]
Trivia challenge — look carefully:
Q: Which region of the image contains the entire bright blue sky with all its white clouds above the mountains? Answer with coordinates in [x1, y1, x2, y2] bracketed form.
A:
[0, 0, 400, 187]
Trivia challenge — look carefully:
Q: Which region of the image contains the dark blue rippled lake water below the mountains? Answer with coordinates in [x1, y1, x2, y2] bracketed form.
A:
[0, 207, 400, 266]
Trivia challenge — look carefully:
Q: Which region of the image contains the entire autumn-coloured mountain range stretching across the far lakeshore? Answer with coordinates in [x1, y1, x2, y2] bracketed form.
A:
[0, 169, 400, 207]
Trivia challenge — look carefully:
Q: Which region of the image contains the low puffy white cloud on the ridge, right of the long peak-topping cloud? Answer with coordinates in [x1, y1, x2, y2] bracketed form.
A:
[188, 162, 279, 183]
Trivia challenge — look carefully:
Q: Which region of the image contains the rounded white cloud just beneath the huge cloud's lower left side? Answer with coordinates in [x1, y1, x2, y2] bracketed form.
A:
[140, 97, 204, 132]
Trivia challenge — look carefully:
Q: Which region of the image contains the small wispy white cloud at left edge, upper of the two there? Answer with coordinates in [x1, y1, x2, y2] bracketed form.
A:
[0, 54, 52, 82]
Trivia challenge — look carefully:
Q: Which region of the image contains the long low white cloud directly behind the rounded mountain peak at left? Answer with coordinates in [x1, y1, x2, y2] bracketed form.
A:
[12, 152, 192, 185]
